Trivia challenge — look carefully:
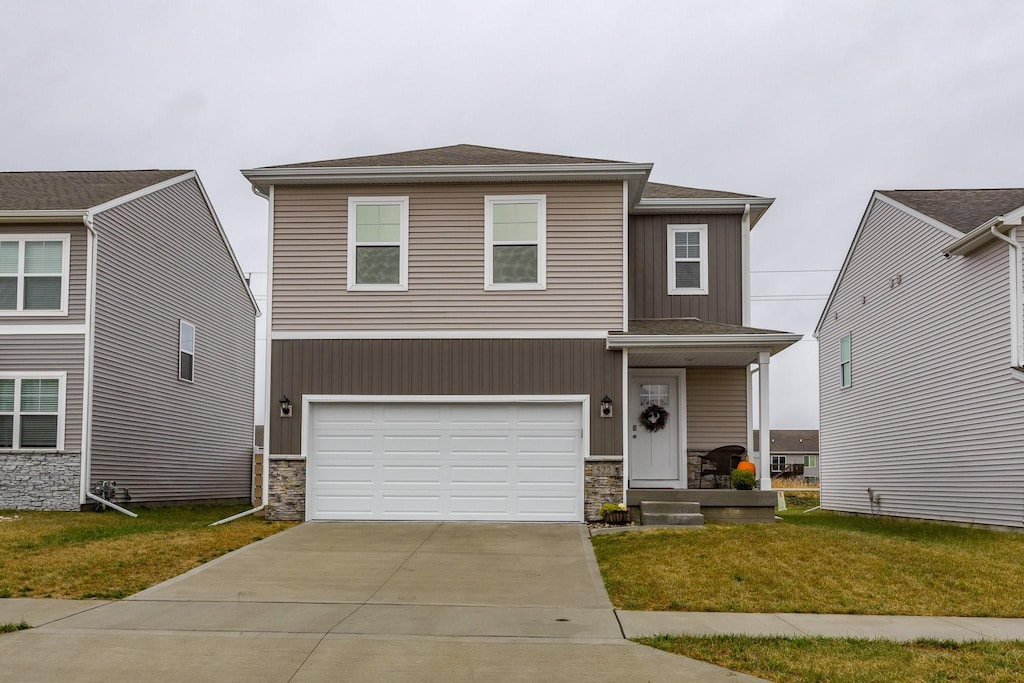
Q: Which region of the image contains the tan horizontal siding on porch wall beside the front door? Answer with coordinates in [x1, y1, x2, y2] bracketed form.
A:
[686, 368, 748, 450]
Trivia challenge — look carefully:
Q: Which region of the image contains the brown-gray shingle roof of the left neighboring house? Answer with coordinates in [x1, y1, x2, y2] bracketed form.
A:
[0, 170, 188, 211]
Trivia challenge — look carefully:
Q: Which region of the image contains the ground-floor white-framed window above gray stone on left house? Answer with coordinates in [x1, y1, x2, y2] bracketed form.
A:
[0, 373, 68, 451]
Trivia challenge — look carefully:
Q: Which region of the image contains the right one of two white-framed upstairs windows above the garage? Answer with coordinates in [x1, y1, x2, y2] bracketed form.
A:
[483, 195, 548, 291]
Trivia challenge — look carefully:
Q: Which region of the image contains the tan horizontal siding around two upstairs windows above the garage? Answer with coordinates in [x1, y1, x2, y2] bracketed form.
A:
[271, 182, 623, 332]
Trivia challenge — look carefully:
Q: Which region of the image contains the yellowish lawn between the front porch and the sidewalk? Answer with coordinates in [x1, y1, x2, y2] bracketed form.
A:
[593, 509, 1024, 617]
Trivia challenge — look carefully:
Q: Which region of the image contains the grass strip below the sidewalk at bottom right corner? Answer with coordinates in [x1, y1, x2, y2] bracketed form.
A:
[637, 636, 1024, 683]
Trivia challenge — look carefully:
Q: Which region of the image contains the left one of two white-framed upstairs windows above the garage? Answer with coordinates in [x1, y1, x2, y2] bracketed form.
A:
[348, 197, 409, 292]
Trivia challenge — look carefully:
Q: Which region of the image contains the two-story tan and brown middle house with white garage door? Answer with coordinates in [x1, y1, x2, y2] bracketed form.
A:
[243, 144, 800, 521]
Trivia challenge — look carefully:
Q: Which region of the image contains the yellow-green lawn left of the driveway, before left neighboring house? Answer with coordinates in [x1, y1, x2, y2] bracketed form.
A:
[0, 506, 293, 598]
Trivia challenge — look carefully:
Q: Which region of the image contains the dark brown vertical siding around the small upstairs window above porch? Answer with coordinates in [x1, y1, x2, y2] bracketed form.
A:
[629, 214, 743, 325]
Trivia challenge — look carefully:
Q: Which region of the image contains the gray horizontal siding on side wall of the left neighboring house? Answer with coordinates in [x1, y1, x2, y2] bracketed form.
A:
[90, 179, 255, 503]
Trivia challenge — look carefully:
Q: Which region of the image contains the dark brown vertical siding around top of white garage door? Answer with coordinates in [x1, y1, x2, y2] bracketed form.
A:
[270, 339, 623, 456]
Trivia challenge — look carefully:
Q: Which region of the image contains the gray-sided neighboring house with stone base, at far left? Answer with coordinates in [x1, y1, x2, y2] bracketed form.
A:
[0, 171, 257, 510]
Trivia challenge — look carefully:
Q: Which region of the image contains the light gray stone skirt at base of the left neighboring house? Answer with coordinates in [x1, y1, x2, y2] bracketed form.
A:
[0, 452, 82, 512]
